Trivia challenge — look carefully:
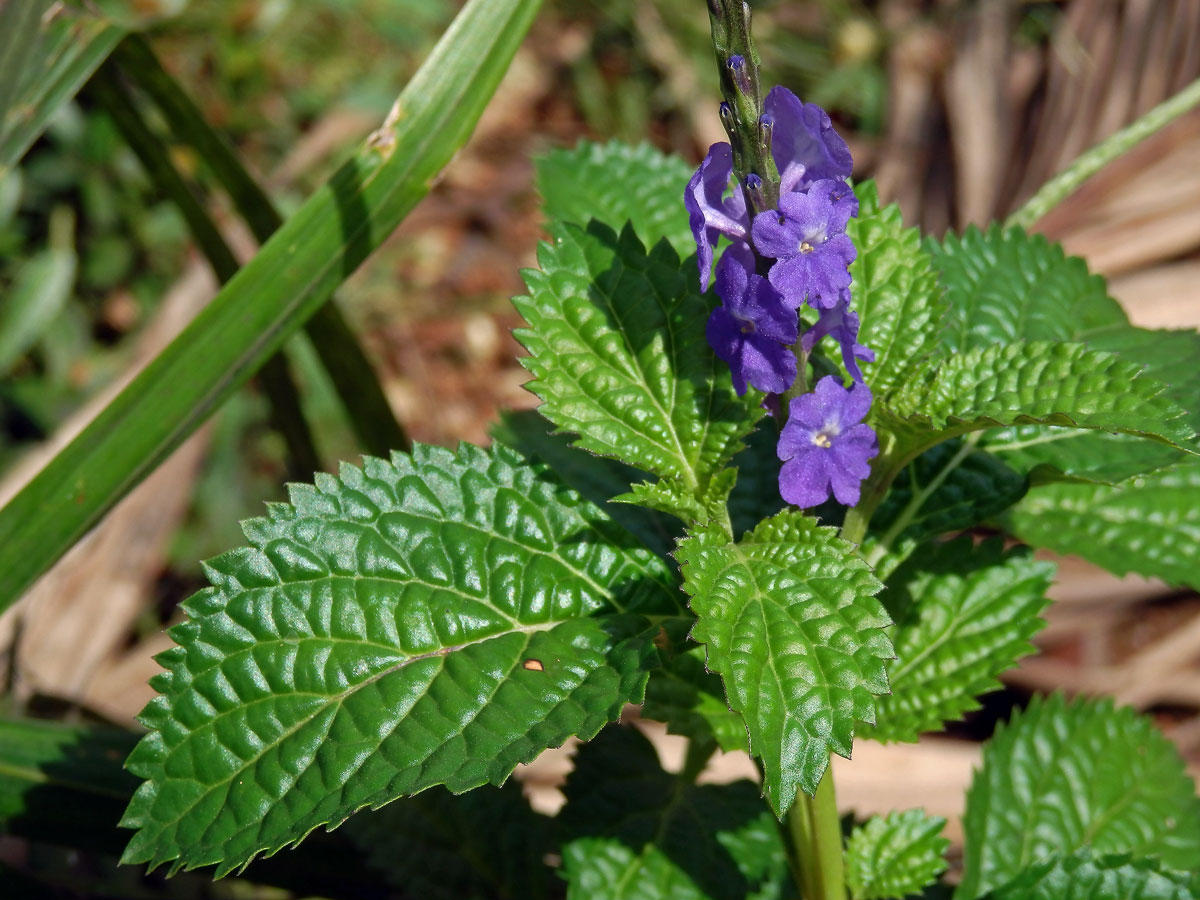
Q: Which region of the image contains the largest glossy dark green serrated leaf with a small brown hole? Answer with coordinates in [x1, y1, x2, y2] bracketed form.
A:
[122, 444, 678, 872]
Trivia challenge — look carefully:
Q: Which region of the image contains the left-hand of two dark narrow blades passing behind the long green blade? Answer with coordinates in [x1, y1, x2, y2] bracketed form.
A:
[88, 61, 320, 480]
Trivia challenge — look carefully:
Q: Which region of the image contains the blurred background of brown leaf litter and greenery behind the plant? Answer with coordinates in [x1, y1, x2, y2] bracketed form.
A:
[0, 0, 1200, 896]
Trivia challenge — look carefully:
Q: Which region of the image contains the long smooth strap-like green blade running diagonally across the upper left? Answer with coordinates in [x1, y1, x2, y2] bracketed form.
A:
[0, 0, 539, 611]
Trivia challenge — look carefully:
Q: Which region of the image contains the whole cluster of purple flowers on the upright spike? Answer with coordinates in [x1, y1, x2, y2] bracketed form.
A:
[684, 87, 877, 506]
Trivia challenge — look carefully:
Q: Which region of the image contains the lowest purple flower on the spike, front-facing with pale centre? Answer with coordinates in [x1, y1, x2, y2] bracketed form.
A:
[776, 376, 880, 509]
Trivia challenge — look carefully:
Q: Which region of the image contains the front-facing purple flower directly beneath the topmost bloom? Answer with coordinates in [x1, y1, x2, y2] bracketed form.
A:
[752, 179, 858, 310]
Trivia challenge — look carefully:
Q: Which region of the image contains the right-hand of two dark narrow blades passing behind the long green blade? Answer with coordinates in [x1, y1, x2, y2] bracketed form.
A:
[114, 35, 412, 458]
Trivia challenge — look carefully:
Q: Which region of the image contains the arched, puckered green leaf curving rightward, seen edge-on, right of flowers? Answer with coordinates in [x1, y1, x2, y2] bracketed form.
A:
[877, 341, 1194, 457]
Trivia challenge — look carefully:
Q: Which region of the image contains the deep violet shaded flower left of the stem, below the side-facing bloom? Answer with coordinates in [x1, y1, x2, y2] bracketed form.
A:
[706, 242, 799, 396]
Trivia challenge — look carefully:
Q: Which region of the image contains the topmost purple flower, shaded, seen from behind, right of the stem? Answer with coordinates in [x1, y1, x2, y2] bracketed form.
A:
[763, 85, 853, 193]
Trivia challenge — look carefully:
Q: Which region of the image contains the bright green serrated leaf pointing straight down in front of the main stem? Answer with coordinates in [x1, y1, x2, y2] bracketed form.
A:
[676, 510, 892, 817]
